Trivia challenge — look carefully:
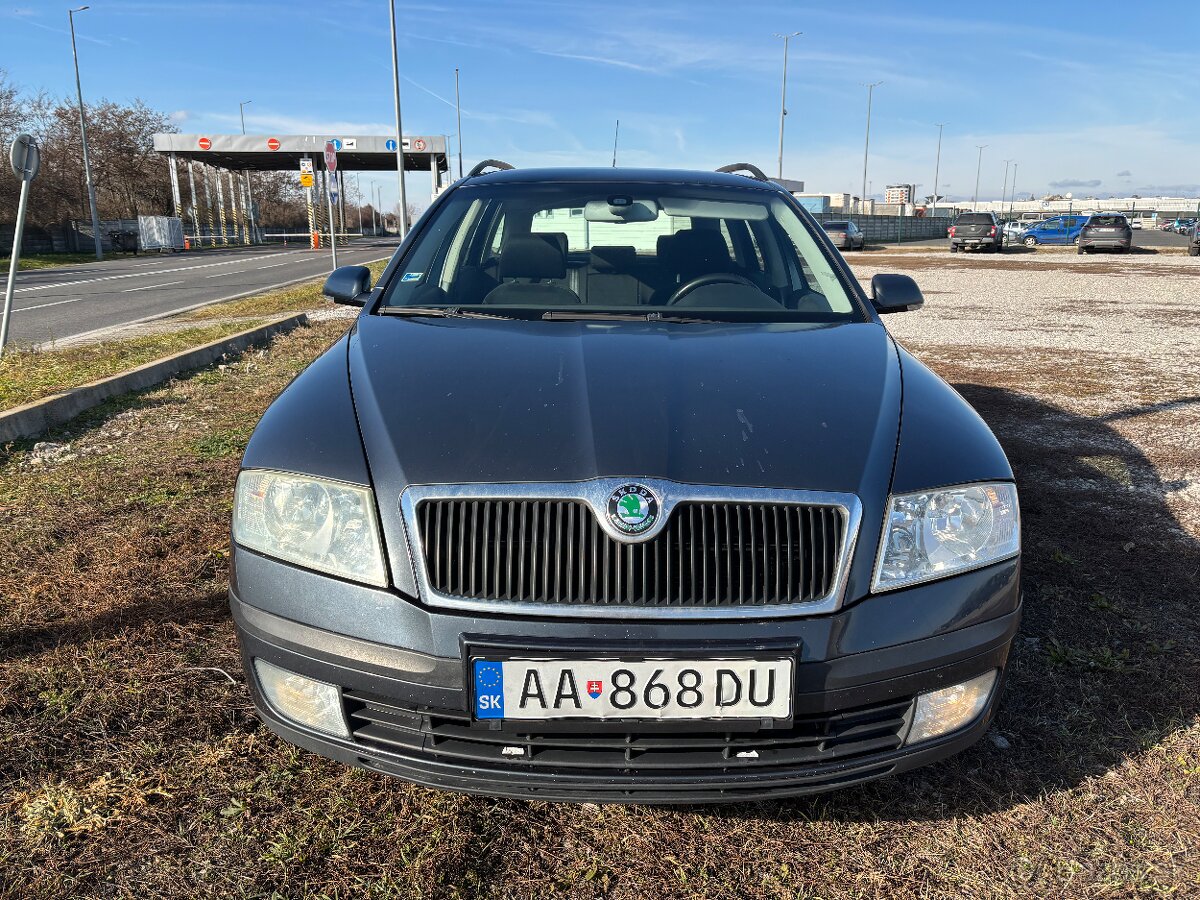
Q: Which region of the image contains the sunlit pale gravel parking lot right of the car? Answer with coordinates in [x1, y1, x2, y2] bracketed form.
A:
[853, 252, 1200, 538]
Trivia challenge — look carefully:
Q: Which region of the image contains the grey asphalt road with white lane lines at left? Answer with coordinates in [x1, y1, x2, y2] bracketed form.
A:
[0, 238, 396, 346]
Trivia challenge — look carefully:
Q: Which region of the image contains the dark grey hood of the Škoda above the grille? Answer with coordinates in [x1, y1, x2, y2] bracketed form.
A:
[349, 316, 900, 503]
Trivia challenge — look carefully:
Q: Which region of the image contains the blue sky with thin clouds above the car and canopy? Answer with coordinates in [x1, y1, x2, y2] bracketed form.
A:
[0, 0, 1200, 212]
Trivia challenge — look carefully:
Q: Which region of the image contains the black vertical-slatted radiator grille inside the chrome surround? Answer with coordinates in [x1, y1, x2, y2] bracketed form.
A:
[415, 497, 847, 608]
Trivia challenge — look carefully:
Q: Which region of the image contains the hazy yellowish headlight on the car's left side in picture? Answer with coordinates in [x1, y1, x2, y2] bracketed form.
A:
[233, 469, 388, 587]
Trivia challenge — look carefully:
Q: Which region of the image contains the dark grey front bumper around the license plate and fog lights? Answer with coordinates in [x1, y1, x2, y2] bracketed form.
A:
[230, 551, 1020, 803]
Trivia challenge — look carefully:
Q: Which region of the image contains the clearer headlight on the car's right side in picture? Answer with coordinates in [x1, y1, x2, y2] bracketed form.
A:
[871, 482, 1021, 590]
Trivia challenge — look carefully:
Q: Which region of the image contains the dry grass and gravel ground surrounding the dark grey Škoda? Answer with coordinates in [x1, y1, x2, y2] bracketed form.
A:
[0, 253, 1200, 900]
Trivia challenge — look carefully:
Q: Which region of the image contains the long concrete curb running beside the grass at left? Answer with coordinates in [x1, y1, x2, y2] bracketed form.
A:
[0, 313, 308, 443]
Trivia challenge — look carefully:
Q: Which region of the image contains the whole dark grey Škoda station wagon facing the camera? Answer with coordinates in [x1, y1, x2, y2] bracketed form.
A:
[230, 162, 1020, 803]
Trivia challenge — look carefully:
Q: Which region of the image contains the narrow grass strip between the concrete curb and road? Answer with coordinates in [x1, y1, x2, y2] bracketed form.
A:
[0, 319, 263, 409]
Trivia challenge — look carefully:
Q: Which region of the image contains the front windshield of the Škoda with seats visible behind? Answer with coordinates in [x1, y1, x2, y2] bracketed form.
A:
[378, 182, 863, 322]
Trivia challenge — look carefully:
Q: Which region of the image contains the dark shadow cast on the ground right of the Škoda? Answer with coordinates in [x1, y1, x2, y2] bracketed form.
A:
[713, 384, 1200, 821]
